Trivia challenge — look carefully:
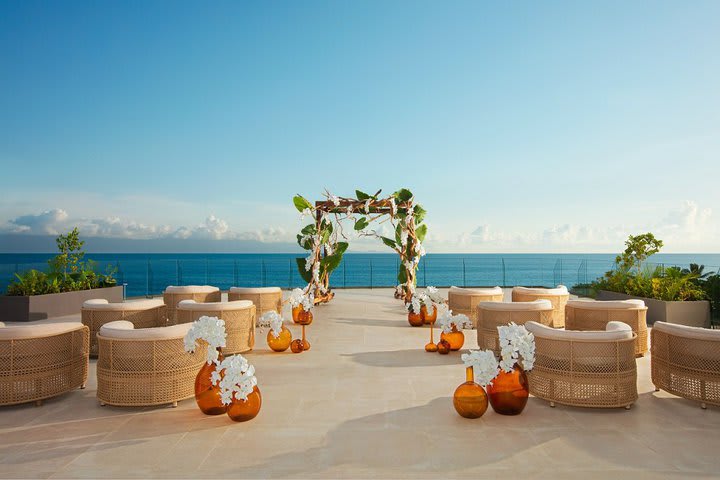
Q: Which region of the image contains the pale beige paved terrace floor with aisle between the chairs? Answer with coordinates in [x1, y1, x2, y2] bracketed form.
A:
[0, 289, 720, 480]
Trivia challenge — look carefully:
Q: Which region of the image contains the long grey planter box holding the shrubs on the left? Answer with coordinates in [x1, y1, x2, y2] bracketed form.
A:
[0, 286, 123, 322]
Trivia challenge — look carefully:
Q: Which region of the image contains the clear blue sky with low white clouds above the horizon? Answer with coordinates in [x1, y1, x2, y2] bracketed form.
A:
[0, 0, 720, 253]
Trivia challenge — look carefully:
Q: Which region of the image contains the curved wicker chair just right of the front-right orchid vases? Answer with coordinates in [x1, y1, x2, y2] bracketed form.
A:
[525, 322, 637, 409]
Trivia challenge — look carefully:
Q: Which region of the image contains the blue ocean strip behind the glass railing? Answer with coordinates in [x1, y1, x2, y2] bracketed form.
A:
[0, 253, 720, 297]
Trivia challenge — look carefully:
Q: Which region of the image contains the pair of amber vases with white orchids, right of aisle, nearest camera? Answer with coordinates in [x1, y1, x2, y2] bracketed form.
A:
[453, 323, 535, 418]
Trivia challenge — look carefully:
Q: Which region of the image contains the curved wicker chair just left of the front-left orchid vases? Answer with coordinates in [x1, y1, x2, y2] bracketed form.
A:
[97, 320, 207, 407]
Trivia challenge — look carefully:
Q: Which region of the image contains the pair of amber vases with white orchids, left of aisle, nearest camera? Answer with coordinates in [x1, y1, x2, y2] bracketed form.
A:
[185, 316, 262, 422]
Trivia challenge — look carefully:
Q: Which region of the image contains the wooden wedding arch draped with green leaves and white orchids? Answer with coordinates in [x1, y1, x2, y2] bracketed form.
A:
[293, 188, 427, 300]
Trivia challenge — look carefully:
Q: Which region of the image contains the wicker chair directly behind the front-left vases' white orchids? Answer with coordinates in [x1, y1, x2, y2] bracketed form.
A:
[177, 300, 256, 355]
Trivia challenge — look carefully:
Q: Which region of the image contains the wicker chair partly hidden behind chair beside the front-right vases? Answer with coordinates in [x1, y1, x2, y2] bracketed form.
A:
[565, 300, 648, 357]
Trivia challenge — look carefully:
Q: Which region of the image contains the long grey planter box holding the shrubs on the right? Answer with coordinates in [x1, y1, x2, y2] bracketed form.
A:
[597, 290, 710, 328]
